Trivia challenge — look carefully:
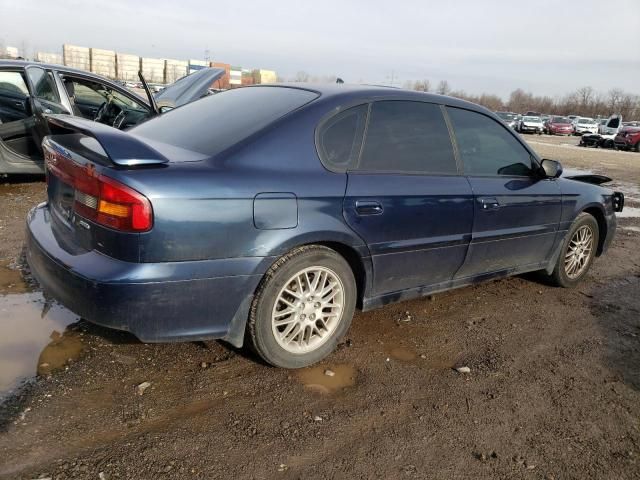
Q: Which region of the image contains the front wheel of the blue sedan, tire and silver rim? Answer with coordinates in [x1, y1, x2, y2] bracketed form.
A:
[550, 212, 600, 288]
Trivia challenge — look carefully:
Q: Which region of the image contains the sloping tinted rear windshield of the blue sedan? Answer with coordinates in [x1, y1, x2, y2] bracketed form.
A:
[130, 87, 318, 156]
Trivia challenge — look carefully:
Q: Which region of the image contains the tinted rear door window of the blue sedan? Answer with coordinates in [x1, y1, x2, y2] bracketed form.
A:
[358, 101, 457, 174]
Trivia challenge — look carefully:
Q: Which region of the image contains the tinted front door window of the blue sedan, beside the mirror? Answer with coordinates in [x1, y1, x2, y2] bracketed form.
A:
[447, 108, 532, 175]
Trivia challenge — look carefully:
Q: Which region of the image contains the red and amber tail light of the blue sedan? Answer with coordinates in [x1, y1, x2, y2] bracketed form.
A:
[45, 148, 153, 232]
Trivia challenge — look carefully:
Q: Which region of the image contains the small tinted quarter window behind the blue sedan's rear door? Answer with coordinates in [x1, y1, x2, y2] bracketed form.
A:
[318, 105, 368, 171]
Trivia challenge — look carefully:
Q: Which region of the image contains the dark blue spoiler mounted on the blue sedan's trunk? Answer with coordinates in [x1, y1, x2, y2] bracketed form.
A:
[46, 115, 169, 167]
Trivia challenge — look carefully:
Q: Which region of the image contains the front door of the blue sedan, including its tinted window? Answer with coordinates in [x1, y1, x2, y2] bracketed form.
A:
[447, 107, 562, 278]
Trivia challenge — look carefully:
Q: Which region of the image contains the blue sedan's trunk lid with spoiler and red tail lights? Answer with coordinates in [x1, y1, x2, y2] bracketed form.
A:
[42, 116, 168, 261]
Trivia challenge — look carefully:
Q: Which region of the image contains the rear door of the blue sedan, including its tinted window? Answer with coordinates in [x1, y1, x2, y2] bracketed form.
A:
[344, 101, 473, 295]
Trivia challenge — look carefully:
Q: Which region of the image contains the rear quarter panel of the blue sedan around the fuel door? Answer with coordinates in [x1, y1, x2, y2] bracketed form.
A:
[107, 105, 366, 262]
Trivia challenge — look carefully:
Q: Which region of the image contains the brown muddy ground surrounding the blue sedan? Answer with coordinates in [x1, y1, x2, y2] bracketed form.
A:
[0, 136, 640, 479]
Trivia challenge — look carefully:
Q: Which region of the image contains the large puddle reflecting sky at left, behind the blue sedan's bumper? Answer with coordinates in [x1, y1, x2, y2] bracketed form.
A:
[0, 290, 83, 401]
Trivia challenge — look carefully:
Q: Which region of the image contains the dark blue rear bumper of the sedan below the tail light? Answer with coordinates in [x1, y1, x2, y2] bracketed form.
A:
[27, 205, 270, 346]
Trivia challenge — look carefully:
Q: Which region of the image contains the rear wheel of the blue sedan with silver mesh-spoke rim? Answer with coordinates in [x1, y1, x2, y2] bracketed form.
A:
[247, 245, 357, 368]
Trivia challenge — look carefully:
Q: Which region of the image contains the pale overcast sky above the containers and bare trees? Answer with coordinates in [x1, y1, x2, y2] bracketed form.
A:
[0, 0, 640, 97]
